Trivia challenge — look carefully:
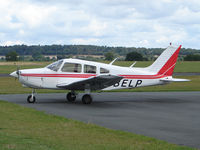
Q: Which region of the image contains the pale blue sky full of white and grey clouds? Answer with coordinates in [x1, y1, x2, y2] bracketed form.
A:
[0, 0, 200, 49]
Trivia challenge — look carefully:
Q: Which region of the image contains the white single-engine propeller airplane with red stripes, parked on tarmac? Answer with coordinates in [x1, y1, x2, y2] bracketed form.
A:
[10, 45, 189, 104]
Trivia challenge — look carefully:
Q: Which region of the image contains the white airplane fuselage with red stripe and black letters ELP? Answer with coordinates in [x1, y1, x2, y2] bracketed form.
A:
[13, 59, 166, 90]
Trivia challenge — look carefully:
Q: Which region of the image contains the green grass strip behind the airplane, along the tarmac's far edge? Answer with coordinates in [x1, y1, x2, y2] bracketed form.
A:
[0, 76, 200, 94]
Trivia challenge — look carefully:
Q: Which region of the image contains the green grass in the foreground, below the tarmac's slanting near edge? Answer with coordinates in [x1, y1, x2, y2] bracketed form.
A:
[0, 101, 193, 150]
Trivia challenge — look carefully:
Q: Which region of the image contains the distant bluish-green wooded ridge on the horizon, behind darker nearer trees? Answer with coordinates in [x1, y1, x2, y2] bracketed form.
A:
[0, 45, 200, 56]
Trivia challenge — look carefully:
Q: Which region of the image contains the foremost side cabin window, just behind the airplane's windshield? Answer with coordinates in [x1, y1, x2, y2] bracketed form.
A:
[61, 63, 81, 73]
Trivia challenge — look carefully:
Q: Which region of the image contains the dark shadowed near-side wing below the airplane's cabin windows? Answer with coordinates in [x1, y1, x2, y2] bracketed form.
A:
[57, 75, 123, 90]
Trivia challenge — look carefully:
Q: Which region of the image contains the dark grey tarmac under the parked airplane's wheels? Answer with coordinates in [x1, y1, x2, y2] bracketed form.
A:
[0, 92, 200, 148]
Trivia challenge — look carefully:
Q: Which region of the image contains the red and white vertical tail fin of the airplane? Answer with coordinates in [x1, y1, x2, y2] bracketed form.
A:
[146, 45, 181, 76]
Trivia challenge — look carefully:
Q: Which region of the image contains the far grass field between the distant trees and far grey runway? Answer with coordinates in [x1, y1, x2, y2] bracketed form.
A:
[0, 61, 200, 74]
